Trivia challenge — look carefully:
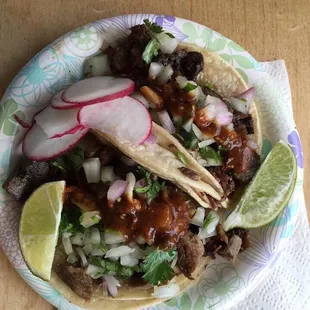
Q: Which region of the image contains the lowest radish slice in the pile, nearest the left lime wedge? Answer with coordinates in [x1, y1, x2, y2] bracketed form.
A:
[23, 124, 88, 161]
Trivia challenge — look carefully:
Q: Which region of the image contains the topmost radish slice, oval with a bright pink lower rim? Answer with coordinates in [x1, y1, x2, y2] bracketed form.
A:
[62, 76, 135, 107]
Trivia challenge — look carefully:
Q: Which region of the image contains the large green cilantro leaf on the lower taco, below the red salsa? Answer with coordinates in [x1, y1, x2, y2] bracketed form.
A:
[141, 249, 176, 285]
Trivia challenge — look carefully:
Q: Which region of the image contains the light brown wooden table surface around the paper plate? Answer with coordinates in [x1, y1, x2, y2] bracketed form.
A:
[0, 0, 310, 310]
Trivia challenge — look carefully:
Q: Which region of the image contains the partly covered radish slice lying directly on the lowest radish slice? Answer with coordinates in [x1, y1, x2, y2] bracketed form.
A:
[34, 106, 83, 139]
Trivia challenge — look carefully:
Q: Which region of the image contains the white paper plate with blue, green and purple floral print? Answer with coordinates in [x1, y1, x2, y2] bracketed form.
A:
[0, 14, 303, 310]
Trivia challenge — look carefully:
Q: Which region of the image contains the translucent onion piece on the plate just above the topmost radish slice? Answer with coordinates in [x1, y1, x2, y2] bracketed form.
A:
[83, 54, 111, 77]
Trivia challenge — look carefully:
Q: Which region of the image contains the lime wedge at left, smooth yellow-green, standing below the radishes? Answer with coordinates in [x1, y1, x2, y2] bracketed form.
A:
[19, 181, 66, 281]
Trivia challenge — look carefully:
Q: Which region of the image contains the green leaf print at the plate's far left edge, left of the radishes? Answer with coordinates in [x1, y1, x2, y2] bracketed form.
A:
[0, 99, 25, 136]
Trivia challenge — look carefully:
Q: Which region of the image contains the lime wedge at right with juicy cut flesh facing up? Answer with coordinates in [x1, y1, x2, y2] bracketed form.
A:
[223, 141, 297, 231]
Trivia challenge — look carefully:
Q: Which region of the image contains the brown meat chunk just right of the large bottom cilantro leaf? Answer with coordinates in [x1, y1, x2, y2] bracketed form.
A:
[177, 235, 204, 279]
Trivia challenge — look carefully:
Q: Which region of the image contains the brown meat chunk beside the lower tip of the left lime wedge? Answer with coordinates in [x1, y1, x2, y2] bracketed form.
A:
[56, 265, 97, 300]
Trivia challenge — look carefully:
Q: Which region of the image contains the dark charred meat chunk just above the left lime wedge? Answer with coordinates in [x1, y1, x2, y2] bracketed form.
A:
[2, 161, 55, 200]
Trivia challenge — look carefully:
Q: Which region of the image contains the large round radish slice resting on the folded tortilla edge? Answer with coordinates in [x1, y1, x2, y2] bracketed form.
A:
[78, 97, 152, 144]
